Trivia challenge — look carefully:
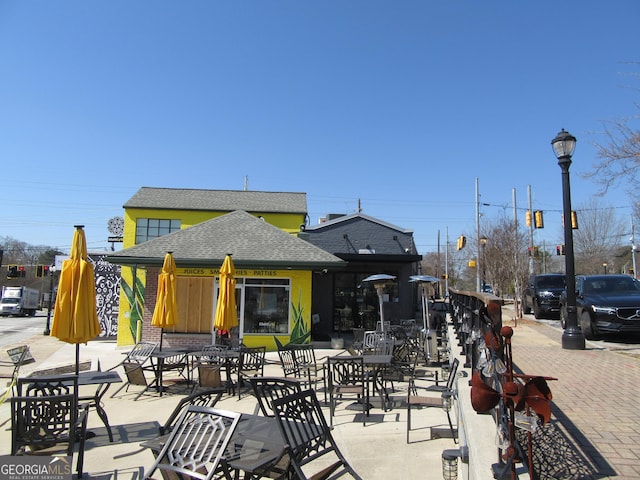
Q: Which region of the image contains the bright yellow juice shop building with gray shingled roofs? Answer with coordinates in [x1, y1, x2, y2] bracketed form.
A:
[106, 188, 345, 349]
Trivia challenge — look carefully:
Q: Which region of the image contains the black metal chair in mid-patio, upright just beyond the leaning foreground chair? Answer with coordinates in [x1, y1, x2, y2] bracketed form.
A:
[328, 356, 369, 425]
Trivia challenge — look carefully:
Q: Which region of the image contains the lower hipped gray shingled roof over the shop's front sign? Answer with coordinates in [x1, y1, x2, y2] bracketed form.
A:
[105, 210, 345, 270]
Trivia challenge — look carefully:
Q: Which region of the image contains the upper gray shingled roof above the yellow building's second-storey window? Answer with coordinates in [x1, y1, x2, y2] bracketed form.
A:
[124, 187, 307, 215]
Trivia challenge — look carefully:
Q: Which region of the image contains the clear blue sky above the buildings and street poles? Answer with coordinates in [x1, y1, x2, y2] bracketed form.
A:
[0, 0, 640, 253]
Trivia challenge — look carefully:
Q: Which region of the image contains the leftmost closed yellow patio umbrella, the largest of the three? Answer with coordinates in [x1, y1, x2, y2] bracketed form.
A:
[51, 225, 101, 374]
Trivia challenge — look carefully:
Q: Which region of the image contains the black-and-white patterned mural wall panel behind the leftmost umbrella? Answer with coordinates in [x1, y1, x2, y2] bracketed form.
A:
[89, 255, 120, 338]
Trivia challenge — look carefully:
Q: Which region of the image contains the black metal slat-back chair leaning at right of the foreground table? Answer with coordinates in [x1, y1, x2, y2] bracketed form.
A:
[273, 389, 361, 480]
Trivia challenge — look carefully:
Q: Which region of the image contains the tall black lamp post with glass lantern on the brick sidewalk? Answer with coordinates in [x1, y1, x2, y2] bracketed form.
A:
[551, 129, 585, 350]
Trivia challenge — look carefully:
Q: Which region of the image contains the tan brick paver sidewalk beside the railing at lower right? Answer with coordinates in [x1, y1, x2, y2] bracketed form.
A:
[505, 321, 640, 479]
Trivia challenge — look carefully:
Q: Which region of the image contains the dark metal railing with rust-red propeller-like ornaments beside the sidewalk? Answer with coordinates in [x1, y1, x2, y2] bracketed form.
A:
[443, 290, 555, 479]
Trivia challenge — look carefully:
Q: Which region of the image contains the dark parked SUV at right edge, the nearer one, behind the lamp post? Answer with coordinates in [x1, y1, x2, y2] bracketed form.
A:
[560, 275, 640, 340]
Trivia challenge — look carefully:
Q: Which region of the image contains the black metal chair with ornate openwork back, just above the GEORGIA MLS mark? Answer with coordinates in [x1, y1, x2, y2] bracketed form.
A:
[11, 393, 88, 478]
